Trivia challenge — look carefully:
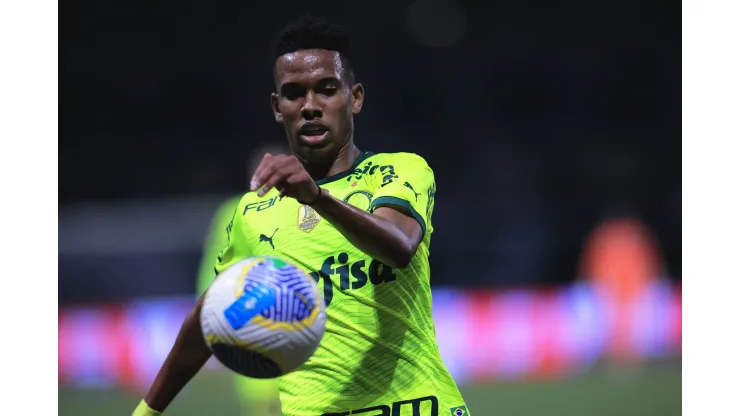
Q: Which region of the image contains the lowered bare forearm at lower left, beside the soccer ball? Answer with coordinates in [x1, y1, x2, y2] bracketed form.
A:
[144, 297, 211, 411]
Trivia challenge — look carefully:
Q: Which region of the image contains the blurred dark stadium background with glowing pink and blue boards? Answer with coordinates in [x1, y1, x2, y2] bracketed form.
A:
[59, 0, 681, 416]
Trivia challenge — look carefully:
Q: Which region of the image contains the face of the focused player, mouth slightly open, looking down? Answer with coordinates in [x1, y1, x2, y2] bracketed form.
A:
[271, 49, 363, 160]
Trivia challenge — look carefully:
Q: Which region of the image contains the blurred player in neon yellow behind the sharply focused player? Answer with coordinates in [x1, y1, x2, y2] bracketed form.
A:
[196, 144, 287, 416]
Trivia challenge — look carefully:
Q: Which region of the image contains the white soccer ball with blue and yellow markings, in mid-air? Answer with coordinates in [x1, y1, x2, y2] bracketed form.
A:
[200, 257, 326, 378]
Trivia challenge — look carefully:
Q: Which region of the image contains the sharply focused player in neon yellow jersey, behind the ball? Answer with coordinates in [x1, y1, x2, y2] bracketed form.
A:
[134, 14, 468, 416]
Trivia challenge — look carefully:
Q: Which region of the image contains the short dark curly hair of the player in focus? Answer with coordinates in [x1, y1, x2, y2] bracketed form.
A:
[271, 14, 355, 83]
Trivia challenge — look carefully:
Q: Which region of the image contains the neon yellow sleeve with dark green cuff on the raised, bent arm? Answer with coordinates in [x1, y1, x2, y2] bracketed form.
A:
[370, 153, 436, 235]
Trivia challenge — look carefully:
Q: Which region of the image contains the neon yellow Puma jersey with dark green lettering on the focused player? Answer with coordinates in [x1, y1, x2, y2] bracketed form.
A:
[216, 153, 468, 416]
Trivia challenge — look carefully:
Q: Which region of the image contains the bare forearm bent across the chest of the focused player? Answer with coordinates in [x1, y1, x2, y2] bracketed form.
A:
[312, 192, 416, 268]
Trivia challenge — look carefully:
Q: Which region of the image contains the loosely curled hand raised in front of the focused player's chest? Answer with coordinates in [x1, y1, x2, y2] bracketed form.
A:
[249, 153, 320, 203]
